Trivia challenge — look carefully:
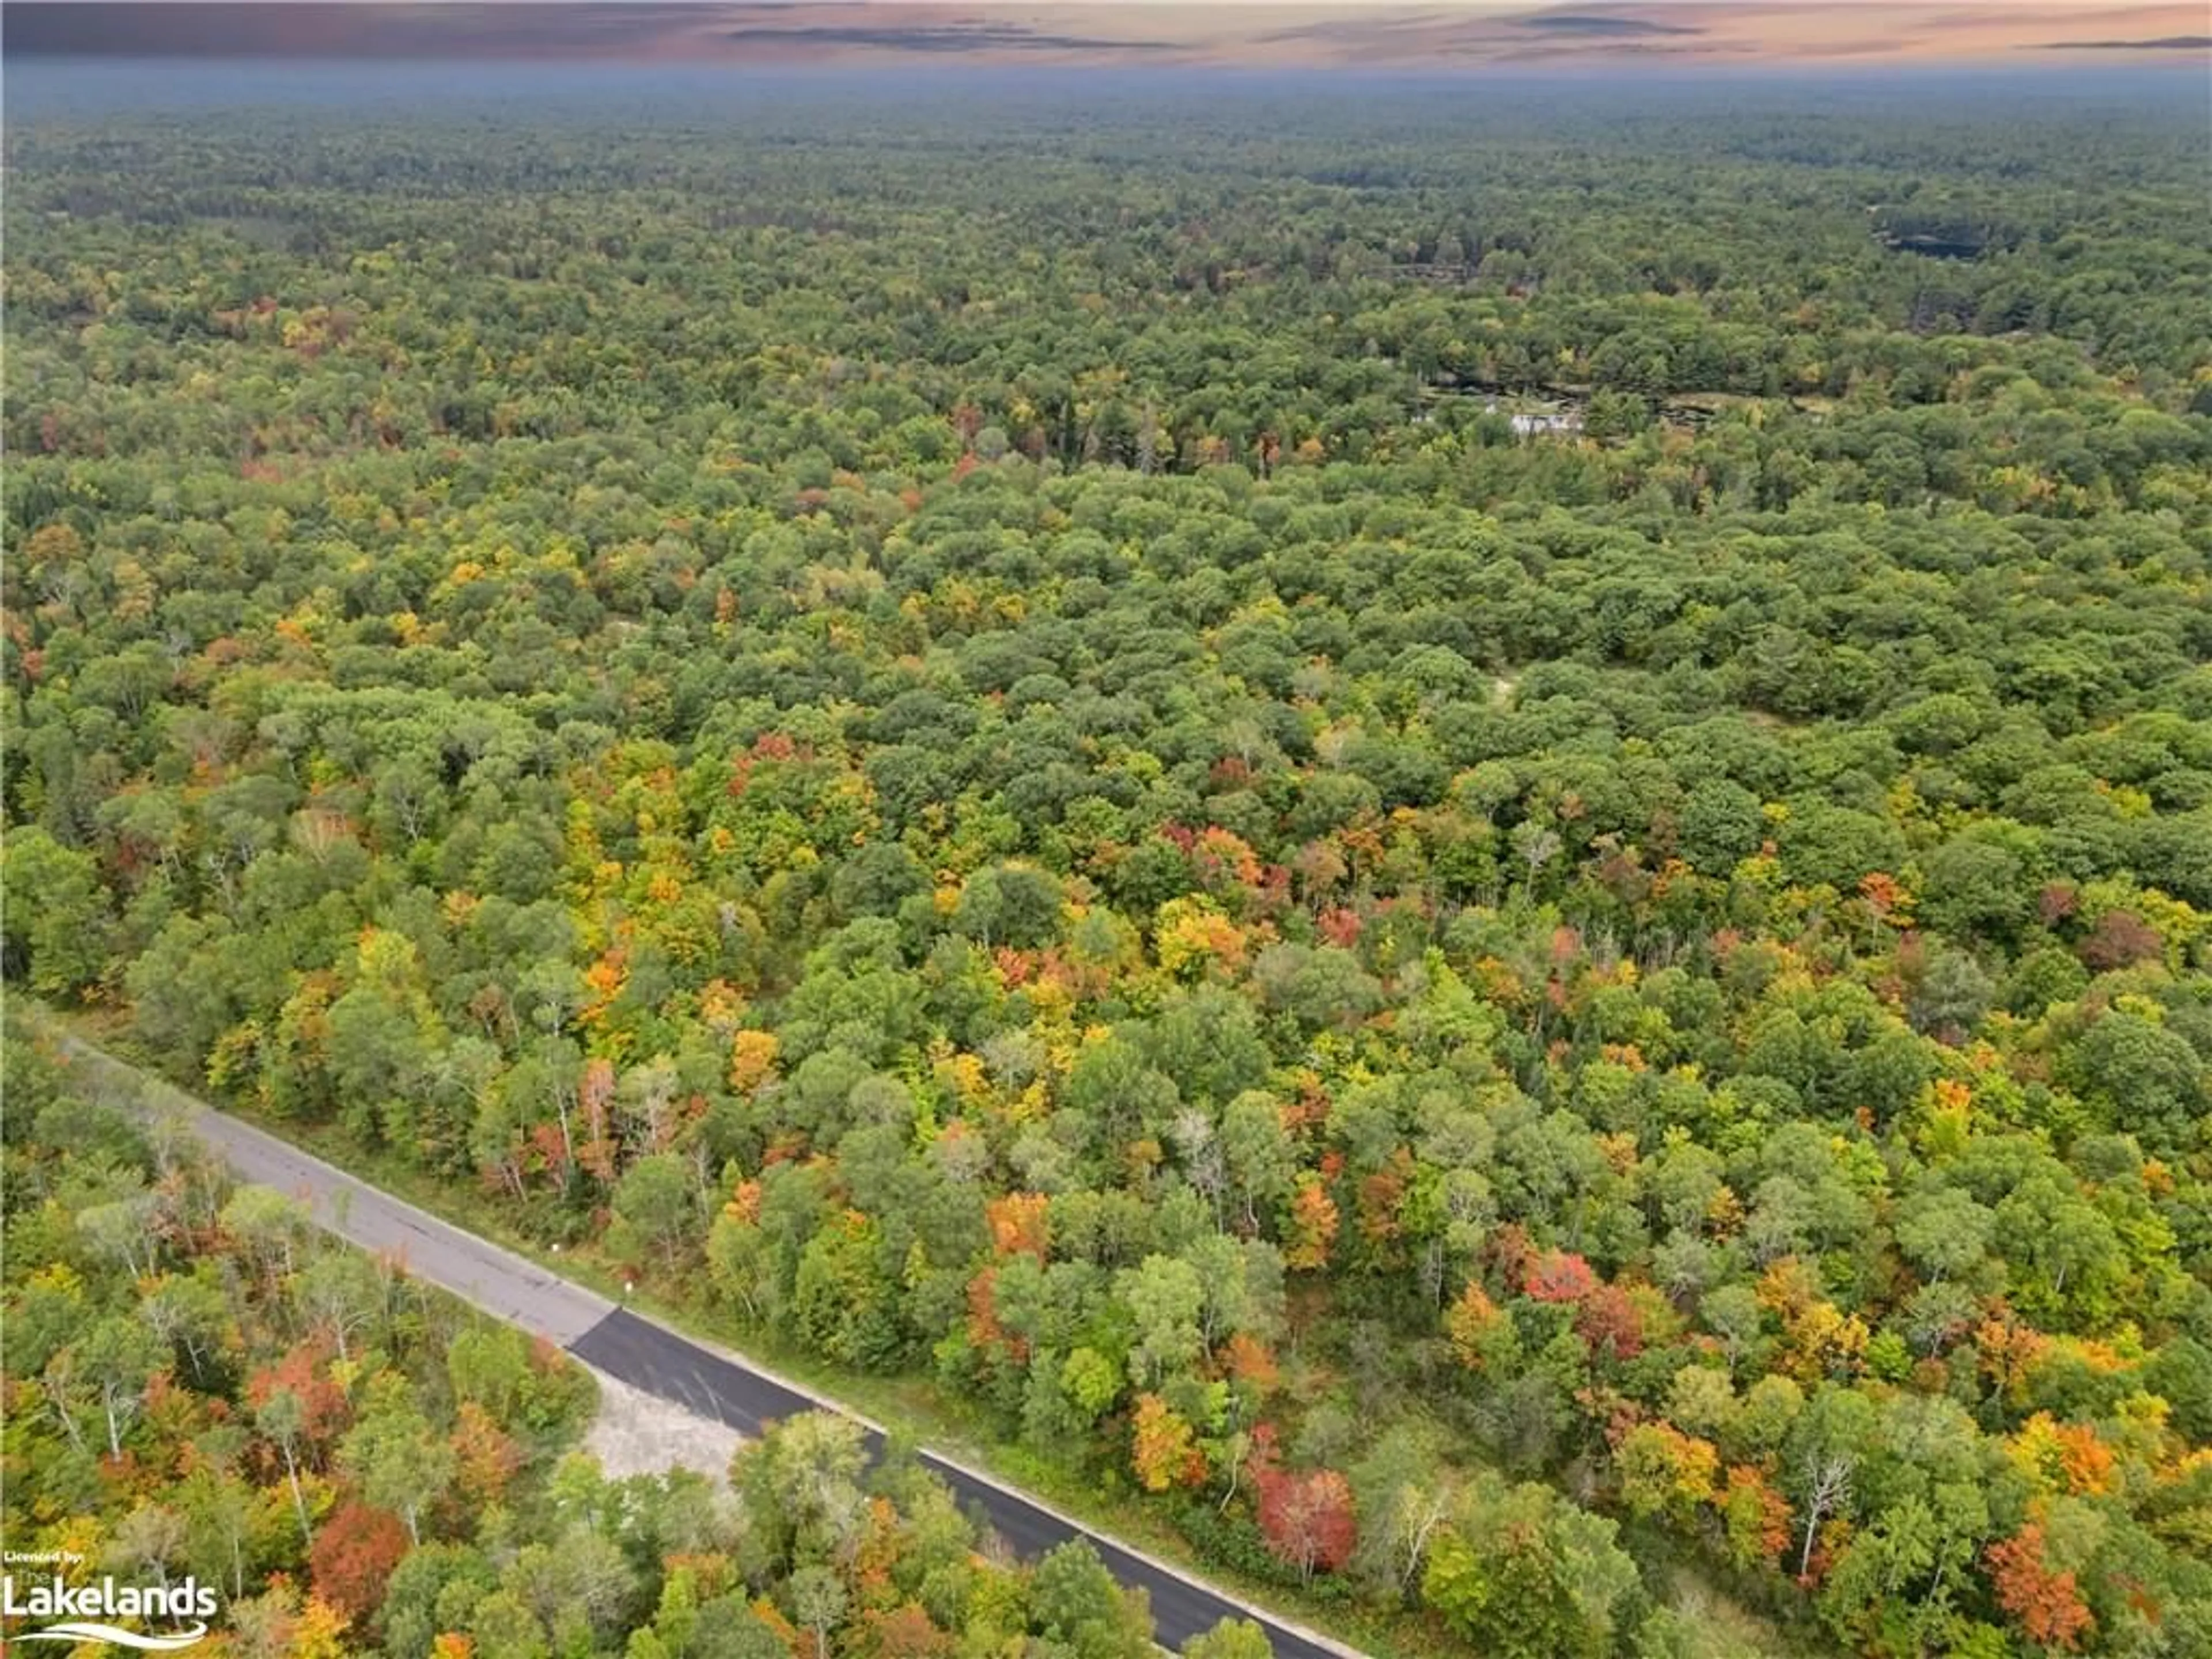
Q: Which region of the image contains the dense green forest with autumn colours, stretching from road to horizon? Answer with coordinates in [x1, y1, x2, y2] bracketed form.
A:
[0, 71, 2212, 1659]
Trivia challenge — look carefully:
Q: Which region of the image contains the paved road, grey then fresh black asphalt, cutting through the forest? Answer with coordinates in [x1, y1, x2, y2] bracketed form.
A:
[64, 1037, 1362, 1659]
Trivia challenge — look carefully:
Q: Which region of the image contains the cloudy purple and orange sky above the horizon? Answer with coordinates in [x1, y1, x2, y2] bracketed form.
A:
[5, 0, 2212, 71]
